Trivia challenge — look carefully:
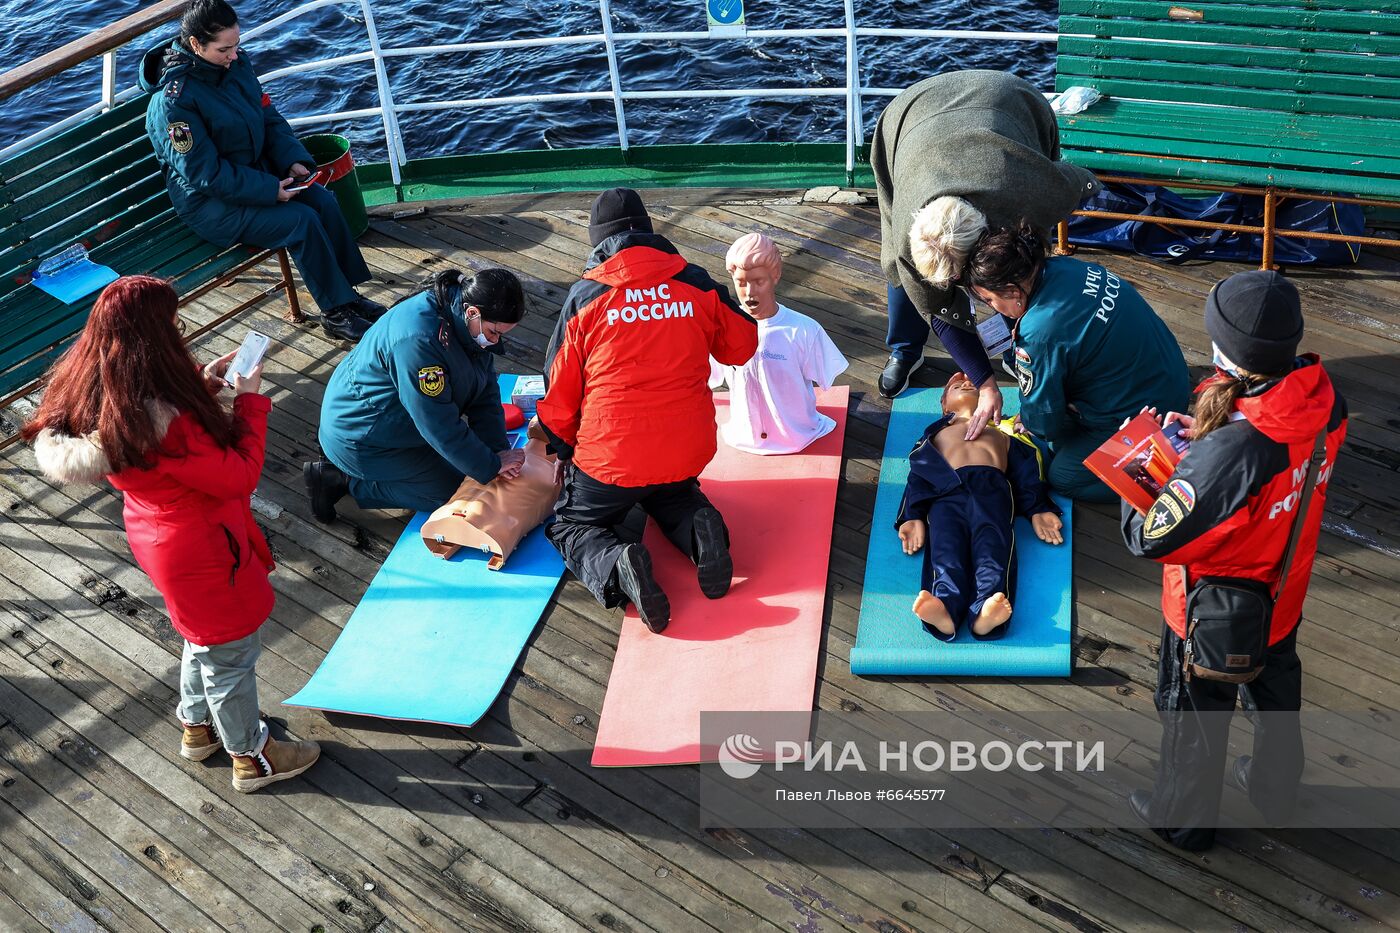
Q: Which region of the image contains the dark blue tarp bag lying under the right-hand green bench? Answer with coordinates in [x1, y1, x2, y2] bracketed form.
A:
[1070, 185, 1365, 266]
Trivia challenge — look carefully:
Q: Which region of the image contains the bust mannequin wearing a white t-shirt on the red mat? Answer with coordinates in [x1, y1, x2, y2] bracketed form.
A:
[710, 234, 846, 454]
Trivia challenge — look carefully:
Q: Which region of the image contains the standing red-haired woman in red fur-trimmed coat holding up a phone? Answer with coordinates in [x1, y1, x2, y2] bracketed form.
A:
[24, 276, 321, 793]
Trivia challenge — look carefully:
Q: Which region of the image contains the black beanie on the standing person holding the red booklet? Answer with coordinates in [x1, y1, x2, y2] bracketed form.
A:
[1205, 269, 1303, 375]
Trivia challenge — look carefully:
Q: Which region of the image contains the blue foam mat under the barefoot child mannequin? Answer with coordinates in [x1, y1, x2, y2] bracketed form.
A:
[851, 388, 1074, 677]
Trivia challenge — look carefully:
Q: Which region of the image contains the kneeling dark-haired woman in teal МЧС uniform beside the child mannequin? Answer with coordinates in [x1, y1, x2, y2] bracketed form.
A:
[962, 224, 1191, 502]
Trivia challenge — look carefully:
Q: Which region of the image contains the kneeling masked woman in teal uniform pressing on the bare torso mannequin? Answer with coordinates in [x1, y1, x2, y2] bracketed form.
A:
[302, 269, 525, 521]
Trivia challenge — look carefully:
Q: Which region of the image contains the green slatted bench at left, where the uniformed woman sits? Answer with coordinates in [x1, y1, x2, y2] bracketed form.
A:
[0, 95, 301, 447]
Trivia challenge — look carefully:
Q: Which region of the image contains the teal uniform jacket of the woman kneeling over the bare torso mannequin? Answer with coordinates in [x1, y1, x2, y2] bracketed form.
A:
[319, 291, 510, 483]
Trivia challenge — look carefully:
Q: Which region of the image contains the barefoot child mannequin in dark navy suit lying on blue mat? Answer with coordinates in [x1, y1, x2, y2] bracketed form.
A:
[895, 373, 1064, 642]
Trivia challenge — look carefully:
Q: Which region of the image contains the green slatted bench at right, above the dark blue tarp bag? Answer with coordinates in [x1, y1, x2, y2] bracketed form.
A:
[1056, 0, 1400, 268]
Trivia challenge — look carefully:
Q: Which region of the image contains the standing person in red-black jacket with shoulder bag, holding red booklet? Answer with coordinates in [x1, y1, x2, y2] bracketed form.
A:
[1123, 272, 1347, 850]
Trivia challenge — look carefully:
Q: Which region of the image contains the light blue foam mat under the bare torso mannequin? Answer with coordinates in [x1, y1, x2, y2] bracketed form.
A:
[286, 375, 564, 726]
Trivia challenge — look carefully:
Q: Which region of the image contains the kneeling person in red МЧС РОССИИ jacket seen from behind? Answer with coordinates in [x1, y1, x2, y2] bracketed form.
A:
[538, 188, 759, 632]
